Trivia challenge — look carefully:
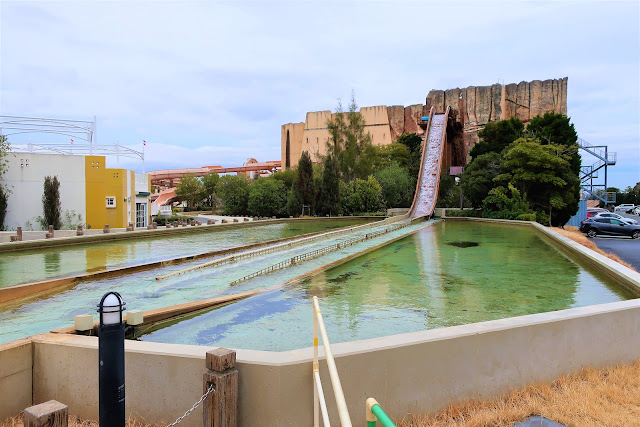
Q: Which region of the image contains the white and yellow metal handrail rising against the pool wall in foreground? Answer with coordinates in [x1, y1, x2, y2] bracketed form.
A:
[313, 296, 351, 427]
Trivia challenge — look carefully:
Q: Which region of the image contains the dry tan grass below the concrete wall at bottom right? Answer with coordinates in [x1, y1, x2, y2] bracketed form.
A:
[397, 360, 640, 427]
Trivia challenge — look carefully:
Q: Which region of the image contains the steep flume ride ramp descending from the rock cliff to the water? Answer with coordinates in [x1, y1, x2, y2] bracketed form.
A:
[408, 107, 449, 218]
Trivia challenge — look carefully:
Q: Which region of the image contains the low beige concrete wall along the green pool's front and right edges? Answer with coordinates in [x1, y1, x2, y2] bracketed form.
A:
[0, 221, 640, 426]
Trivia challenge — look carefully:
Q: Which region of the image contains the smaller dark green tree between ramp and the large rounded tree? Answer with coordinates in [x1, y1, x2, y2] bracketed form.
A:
[461, 152, 502, 208]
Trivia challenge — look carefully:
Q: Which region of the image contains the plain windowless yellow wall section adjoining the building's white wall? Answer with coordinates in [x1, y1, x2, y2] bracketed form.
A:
[84, 156, 107, 229]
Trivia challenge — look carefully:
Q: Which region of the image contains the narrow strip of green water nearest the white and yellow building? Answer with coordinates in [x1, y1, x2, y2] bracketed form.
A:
[0, 220, 367, 287]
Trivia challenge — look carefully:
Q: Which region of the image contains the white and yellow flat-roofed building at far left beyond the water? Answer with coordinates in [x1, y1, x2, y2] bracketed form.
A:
[2, 152, 151, 229]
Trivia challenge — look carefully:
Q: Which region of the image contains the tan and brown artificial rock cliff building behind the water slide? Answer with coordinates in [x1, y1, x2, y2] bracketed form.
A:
[281, 77, 567, 168]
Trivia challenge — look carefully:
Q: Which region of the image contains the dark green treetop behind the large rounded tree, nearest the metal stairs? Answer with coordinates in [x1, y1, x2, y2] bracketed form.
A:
[525, 112, 581, 175]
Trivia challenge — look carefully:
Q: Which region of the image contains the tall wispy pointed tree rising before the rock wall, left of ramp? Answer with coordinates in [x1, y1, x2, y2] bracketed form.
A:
[327, 92, 375, 180]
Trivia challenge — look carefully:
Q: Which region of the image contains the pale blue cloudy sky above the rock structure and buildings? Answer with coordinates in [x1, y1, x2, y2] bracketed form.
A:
[0, 0, 640, 188]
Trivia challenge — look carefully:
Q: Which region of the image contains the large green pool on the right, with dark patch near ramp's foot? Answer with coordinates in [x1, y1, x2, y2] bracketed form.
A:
[142, 221, 636, 351]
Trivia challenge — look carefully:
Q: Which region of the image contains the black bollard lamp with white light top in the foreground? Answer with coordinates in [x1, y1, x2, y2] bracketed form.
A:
[98, 292, 125, 427]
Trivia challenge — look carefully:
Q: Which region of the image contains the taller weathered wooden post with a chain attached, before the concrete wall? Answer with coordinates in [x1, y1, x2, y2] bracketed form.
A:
[202, 348, 238, 427]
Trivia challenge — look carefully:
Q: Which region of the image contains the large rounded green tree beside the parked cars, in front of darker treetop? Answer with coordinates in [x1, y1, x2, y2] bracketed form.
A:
[494, 138, 580, 226]
